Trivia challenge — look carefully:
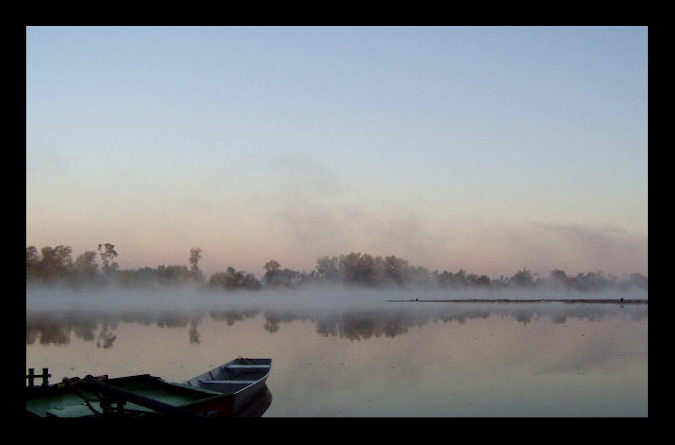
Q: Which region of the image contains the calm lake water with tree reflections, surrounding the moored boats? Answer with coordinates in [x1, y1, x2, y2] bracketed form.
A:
[26, 288, 648, 417]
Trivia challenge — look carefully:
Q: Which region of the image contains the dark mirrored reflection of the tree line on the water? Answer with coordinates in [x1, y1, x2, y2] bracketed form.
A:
[26, 304, 648, 349]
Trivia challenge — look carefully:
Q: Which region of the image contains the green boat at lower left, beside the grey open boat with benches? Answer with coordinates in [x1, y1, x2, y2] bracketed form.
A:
[26, 374, 240, 417]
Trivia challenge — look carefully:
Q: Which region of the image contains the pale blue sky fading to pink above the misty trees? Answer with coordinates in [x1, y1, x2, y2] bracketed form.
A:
[26, 27, 648, 276]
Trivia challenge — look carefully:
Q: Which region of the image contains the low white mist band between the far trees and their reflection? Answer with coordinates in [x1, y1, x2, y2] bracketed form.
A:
[26, 285, 648, 311]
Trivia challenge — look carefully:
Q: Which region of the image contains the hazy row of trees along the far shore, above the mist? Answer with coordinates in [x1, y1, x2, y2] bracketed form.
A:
[26, 243, 648, 292]
